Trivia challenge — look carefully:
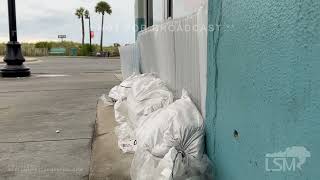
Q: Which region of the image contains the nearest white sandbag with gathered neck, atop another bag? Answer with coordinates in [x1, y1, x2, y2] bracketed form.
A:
[136, 91, 204, 158]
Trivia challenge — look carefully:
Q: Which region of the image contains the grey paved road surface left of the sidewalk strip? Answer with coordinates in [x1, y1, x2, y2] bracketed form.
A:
[0, 57, 120, 180]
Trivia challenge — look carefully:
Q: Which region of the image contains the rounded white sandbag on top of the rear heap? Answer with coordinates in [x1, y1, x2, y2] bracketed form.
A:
[127, 76, 173, 129]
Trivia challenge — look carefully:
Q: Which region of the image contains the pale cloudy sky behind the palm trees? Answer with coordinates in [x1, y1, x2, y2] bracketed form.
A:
[0, 0, 135, 45]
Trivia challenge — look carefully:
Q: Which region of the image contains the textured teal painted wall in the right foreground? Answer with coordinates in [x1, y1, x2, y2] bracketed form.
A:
[206, 0, 320, 180]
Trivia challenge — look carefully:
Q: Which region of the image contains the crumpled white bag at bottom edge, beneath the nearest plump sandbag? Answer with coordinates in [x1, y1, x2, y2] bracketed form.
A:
[131, 147, 214, 180]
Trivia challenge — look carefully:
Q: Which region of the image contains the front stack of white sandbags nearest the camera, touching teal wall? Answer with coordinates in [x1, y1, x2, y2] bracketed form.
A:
[131, 91, 212, 180]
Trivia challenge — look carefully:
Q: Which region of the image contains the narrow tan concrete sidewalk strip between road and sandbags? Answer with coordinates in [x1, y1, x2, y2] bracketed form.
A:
[89, 97, 133, 180]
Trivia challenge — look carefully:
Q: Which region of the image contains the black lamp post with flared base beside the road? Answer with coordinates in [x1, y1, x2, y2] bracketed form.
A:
[0, 0, 31, 77]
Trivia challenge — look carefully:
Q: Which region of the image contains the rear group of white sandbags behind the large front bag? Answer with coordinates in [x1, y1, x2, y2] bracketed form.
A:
[109, 74, 173, 153]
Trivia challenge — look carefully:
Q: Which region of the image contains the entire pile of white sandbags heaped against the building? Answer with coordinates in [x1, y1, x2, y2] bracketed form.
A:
[109, 74, 212, 180]
